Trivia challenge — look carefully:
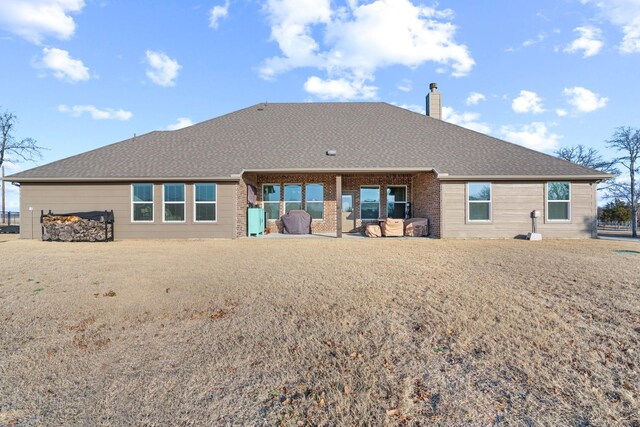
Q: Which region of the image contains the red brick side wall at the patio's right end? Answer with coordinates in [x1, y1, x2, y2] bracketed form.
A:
[412, 172, 441, 238]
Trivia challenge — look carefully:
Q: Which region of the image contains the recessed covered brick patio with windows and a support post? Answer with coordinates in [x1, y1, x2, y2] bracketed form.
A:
[239, 170, 440, 238]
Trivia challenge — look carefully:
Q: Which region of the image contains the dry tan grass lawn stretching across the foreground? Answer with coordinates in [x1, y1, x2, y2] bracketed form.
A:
[0, 235, 640, 427]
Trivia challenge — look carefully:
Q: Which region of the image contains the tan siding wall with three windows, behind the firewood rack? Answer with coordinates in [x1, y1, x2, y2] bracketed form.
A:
[20, 182, 237, 239]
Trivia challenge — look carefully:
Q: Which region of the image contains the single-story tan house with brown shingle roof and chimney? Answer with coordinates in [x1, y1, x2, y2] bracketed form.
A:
[8, 84, 610, 239]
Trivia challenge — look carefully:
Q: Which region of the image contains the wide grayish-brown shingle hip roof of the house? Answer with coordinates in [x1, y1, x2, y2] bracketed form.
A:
[9, 102, 607, 181]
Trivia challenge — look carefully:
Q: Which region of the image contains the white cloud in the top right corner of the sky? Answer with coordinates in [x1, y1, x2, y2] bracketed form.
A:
[582, 0, 640, 53]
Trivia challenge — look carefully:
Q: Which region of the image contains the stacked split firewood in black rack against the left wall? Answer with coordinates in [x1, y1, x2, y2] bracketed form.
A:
[42, 215, 112, 242]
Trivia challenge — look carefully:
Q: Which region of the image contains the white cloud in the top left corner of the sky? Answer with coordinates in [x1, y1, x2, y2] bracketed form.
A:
[0, 0, 84, 44]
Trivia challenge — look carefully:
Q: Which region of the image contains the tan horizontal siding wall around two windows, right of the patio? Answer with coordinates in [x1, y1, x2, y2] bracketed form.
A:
[441, 181, 597, 238]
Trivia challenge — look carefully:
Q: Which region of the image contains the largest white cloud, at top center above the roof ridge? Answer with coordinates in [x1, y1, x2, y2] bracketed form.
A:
[260, 0, 475, 97]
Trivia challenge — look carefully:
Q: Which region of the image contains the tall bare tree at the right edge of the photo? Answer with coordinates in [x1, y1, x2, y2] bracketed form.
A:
[607, 126, 640, 241]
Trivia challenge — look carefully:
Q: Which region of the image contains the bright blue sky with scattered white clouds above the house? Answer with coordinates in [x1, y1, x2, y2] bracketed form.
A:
[0, 0, 640, 210]
